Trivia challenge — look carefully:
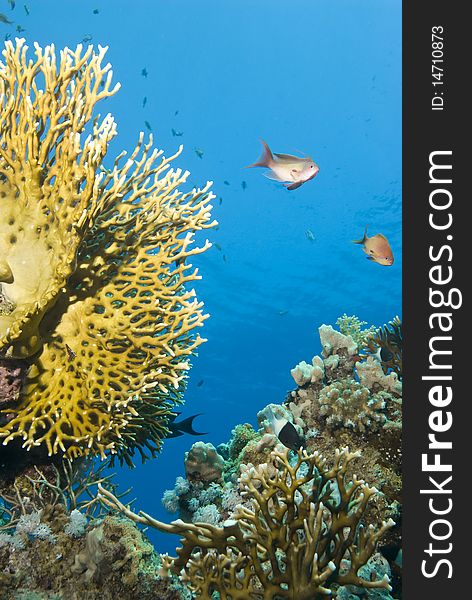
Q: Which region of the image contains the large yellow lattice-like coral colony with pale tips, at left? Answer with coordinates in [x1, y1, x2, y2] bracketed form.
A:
[0, 39, 215, 460]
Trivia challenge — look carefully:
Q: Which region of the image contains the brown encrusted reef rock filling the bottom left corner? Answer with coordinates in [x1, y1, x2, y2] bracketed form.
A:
[0, 516, 190, 600]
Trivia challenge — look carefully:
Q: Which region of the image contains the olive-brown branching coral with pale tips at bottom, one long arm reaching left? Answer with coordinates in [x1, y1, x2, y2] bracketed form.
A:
[99, 448, 393, 600]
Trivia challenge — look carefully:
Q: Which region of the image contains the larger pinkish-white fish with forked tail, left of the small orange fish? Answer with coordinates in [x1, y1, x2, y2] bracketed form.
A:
[247, 140, 320, 190]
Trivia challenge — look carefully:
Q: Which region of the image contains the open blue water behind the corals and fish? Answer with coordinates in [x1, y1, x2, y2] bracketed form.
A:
[9, 0, 401, 552]
